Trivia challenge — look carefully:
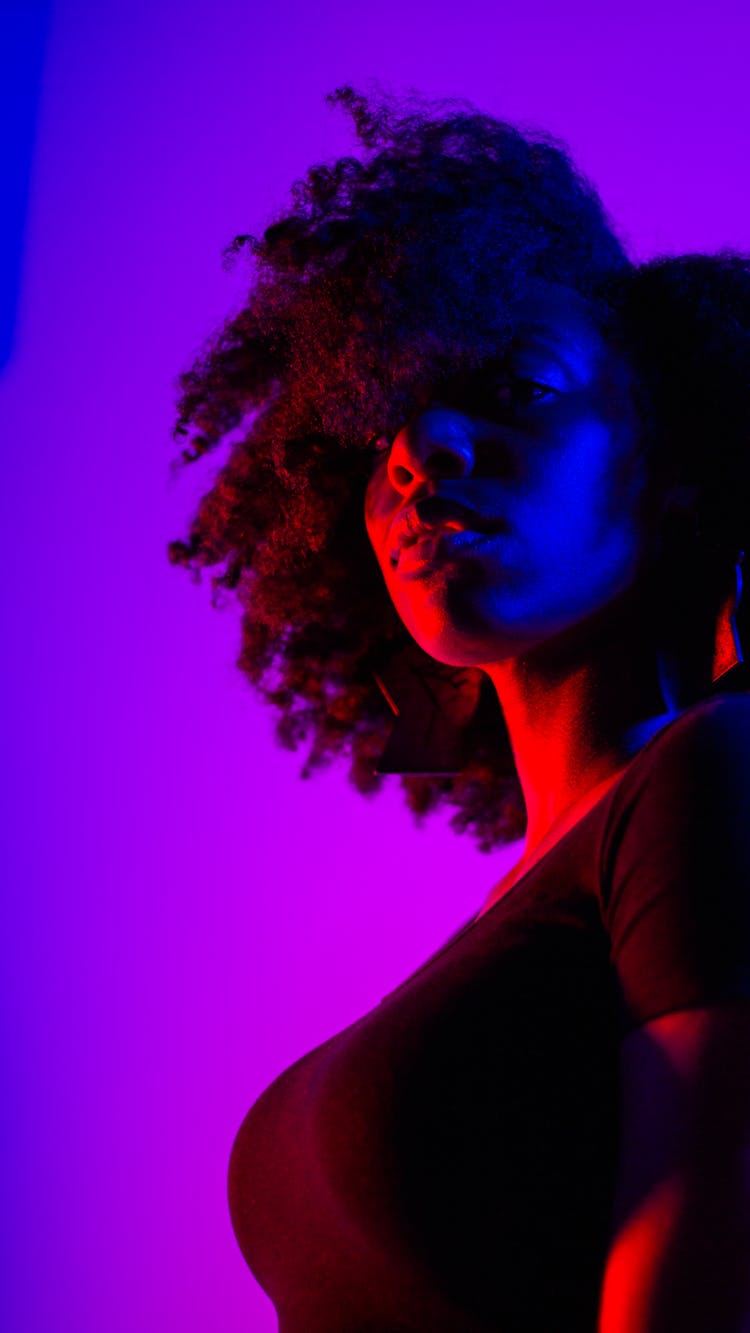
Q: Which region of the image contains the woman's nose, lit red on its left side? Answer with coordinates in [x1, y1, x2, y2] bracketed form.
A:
[388, 407, 474, 492]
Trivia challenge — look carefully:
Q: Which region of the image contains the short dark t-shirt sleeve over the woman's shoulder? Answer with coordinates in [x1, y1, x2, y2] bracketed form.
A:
[599, 694, 750, 1034]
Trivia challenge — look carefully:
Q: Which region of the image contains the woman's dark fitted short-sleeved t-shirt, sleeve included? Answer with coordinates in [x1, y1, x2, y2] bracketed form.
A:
[229, 694, 750, 1333]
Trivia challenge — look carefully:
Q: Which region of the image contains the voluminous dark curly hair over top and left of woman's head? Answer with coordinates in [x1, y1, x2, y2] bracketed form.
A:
[168, 87, 746, 852]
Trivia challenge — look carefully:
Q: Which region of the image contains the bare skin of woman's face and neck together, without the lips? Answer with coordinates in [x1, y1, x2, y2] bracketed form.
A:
[365, 280, 735, 863]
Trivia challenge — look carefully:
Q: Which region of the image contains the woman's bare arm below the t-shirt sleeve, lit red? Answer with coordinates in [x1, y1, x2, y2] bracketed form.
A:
[599, 1000, 750, 1333]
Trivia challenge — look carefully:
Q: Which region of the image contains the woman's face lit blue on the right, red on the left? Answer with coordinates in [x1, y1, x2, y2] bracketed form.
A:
[365, 281, 650, 677]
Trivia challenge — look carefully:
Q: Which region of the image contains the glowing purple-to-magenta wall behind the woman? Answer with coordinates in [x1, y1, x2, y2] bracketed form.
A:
[0, 0, 750, 1333]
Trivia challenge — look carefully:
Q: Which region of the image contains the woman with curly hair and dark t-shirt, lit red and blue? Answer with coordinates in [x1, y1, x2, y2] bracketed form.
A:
[171, 89, 750, 1333]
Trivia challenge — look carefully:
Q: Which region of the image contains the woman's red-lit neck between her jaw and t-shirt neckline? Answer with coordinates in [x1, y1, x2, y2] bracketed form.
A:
[484, 588, 735, 854]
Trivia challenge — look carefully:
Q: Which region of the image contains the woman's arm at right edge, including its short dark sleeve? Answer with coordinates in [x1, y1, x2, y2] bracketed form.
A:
[599, 696, 750, 1333]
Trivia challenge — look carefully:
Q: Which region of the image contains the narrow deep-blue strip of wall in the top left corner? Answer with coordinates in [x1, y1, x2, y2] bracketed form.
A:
[0, 0, 52, 373]
